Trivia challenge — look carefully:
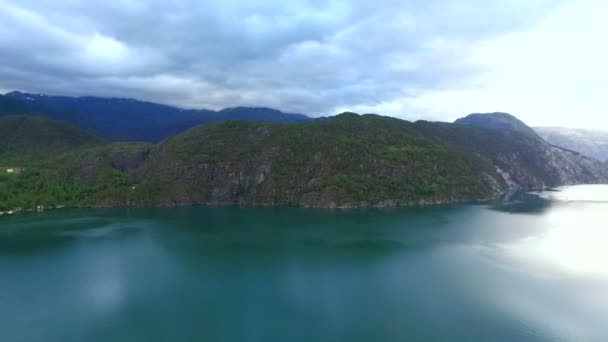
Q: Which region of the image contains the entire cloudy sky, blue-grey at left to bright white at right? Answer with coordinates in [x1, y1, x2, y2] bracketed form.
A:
[0, 0, 608, 129]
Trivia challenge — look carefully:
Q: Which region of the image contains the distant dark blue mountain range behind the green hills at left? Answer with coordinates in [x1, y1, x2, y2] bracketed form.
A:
[0, 92, 310, 142]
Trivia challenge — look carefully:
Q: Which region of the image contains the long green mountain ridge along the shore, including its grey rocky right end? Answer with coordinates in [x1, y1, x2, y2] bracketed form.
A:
[0, 113, 608, 210]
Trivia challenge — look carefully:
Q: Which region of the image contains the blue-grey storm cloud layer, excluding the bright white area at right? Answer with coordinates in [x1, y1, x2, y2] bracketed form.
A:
[0, 0, 554, 114]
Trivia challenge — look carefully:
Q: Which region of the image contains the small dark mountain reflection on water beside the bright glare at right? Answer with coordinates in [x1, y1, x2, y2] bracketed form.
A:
[490, 190, 554, 214]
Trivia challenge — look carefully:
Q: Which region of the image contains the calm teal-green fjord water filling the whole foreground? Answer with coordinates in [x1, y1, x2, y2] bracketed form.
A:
[0, 186, 608, 341]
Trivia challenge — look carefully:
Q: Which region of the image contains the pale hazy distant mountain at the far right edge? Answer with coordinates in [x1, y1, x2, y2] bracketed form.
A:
[534, 127, 608, 161]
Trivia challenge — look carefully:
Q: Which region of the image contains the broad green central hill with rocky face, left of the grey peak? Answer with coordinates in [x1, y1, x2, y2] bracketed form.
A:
[132, 114, 500, 207]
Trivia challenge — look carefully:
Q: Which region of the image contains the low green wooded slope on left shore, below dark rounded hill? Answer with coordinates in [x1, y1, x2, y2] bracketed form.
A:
[0, 143, 150, 212]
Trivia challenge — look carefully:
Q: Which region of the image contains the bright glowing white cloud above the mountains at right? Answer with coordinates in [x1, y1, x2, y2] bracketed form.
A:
[390, 0, 608, 129]
